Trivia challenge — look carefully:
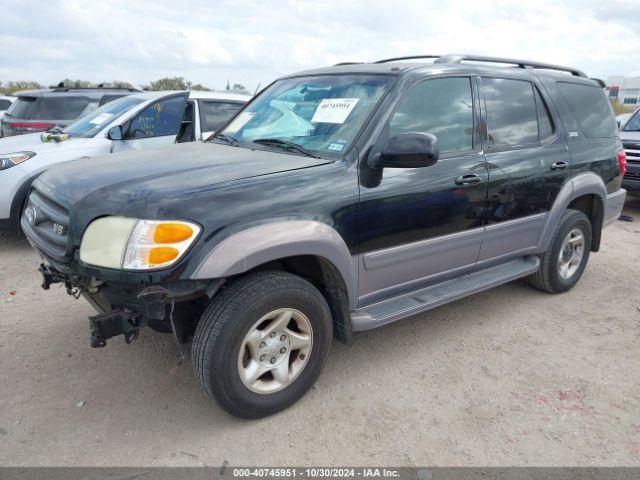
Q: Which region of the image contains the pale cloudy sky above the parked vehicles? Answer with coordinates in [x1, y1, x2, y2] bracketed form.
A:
[0, 0, 640, 90]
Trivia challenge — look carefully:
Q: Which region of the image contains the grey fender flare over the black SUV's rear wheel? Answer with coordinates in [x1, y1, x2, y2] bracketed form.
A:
[538, 172, 607, 252]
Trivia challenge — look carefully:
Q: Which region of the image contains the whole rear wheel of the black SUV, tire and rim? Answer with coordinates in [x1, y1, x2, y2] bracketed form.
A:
[528, 209, 592, 293]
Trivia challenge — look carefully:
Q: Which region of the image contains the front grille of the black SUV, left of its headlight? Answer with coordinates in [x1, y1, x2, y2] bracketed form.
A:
[20, 188, 69, 263]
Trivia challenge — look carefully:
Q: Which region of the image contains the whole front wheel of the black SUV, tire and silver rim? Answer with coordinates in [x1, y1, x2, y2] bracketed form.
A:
[191, 272, 332, 418]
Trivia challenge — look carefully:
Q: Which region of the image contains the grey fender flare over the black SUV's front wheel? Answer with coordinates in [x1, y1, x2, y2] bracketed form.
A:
[191, 220, 358, 310]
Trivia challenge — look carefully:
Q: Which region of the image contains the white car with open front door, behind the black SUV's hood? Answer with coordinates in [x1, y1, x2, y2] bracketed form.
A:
[0, 92, 251, 230]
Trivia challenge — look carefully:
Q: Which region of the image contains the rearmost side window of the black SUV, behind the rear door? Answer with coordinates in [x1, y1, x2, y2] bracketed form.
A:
[558, 82, 617, 138]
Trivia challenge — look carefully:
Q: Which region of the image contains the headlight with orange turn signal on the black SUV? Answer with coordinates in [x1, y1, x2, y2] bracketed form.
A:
[80, 217, 201, 270]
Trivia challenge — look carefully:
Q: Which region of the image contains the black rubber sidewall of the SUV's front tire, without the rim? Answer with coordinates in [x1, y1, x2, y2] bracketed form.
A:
[208, 279, 332, 418]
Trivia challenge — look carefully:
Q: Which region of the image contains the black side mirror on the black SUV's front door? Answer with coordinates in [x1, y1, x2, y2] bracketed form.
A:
[368, 132, 440, 169]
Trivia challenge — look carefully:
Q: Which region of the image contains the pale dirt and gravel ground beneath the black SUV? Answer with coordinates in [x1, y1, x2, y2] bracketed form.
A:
[0, 199, 640, 466]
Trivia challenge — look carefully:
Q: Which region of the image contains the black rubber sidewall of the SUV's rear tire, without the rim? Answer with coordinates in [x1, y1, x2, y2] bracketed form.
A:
[548, 211, 592, 293]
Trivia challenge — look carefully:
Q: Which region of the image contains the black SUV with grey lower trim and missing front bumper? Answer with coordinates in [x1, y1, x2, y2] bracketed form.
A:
[21, 55, 625, 417]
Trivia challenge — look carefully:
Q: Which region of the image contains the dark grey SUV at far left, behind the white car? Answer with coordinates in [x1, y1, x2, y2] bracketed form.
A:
[0, 87, 140, 137]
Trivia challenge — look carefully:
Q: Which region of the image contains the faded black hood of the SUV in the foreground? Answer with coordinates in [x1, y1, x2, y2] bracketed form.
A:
[38, 142, 331, 206]
